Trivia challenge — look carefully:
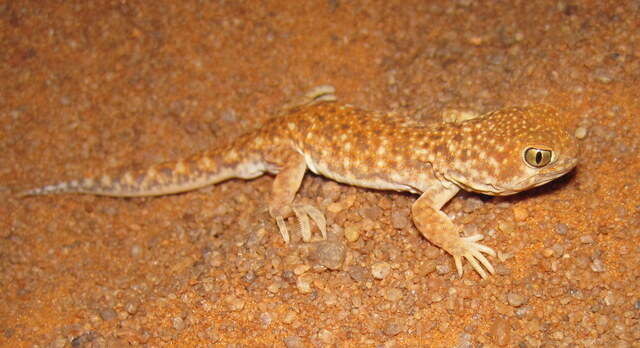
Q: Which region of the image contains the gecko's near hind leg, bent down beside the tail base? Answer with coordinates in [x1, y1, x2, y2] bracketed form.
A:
[269, 151, 327, 243]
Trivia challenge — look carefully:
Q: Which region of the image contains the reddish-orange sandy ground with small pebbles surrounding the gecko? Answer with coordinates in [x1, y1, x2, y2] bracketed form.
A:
[0, 0, 640, 347]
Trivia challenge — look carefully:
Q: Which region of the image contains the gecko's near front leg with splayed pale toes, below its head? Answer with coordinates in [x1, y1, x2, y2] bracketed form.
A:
[411, 185, 496, 278]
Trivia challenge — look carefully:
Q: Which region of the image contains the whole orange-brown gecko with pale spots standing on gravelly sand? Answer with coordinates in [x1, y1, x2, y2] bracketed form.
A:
[21, 90, 578, 278]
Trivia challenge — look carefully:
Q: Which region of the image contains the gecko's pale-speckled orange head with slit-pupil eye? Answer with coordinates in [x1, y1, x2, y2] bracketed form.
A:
[445, 105, 578, 196]
